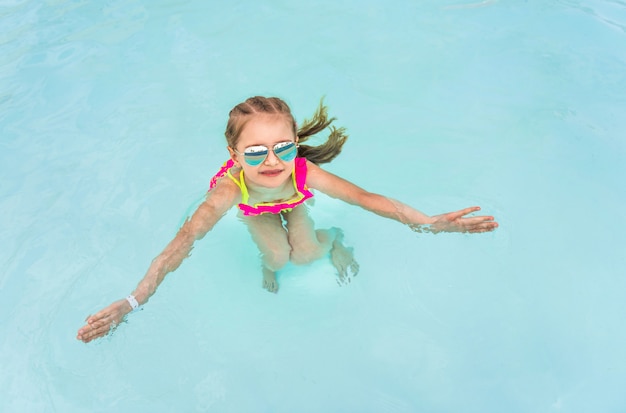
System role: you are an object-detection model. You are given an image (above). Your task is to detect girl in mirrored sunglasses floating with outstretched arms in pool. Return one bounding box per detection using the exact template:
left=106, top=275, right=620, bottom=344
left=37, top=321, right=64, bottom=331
left=77, top=96, right=498, bottom=343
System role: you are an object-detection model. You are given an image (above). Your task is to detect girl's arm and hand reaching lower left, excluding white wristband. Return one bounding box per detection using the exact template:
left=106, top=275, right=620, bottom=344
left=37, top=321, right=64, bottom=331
left=76, top=179, right=240, bottom=343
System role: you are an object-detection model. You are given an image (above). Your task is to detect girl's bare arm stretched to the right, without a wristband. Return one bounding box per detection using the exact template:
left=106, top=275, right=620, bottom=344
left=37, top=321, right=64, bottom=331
left=307, top=162, right=498, bottom=232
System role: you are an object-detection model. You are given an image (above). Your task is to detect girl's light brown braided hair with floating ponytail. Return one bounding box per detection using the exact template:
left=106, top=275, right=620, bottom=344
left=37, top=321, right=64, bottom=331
left=224, top=96, right=348, bottom=164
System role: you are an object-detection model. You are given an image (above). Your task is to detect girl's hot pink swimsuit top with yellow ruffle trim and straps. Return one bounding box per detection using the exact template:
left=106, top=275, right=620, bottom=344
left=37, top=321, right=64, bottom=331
left=209, top=158, right=313, bottom=216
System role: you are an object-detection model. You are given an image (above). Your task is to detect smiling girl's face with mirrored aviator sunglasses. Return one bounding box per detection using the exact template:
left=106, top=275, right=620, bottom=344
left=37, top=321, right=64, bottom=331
left=228, top=114, right=297, bottom=188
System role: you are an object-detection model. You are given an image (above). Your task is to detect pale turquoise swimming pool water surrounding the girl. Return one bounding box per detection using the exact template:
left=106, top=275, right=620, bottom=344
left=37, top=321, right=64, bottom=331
left=0, top=0, right=626, bottom=412
